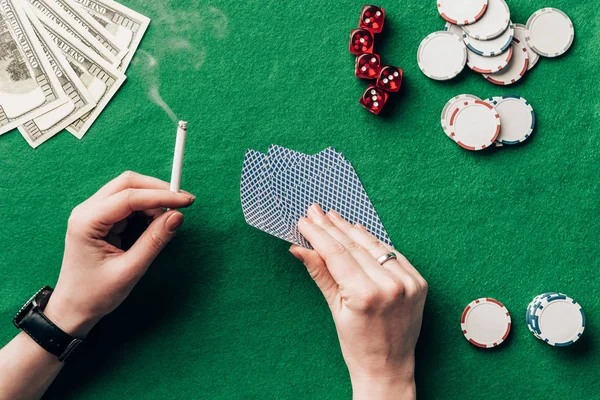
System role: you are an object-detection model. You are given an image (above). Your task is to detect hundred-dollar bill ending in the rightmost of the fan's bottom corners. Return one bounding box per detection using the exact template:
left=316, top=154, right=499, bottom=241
left=38, top=6, right=126, bottom=139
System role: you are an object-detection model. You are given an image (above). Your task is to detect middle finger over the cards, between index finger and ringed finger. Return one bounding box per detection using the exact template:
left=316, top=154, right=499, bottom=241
left=308, top=204, right=391, bottom=284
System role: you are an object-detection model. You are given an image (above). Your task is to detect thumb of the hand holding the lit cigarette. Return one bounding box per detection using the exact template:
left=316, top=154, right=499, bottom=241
left=122, top=210, right=184, bottom=279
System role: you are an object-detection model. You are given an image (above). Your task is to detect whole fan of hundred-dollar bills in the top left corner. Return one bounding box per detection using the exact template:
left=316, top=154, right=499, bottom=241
left=0, top=0, right=150, bottom=148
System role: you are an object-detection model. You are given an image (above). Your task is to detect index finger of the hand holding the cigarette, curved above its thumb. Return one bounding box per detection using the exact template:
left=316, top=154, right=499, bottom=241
left=91, top=189, right=196, bottom=226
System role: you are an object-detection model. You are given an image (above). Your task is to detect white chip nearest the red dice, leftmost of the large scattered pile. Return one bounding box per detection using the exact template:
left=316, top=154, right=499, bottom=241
left=417, top=31, right=467, bottom=81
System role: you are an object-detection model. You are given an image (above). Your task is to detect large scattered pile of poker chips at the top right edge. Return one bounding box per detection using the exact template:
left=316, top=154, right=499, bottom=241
left=417, top=0, right=575, bottom=85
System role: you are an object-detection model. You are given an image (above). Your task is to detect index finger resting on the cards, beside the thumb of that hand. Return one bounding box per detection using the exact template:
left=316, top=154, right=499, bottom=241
left=298, top=214, right=370, bottom=289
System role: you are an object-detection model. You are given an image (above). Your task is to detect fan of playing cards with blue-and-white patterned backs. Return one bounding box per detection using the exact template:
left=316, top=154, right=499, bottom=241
left=240, top=145, right=391, bottom=248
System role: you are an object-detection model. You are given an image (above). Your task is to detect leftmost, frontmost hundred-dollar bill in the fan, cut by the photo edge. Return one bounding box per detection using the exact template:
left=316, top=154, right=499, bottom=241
left=0, top=0, right=67, bottom=135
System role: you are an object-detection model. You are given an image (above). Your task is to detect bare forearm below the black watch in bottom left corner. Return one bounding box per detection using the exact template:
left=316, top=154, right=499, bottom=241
left=0, top=332, right=63, bottom=400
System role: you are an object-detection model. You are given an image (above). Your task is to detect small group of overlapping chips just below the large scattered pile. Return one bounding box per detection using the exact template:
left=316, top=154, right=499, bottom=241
left=441, top=94, right=535, bottom=151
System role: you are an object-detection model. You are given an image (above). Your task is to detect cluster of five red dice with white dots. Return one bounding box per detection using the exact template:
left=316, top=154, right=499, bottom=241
left=350, top=5, right=402, bottom=115
